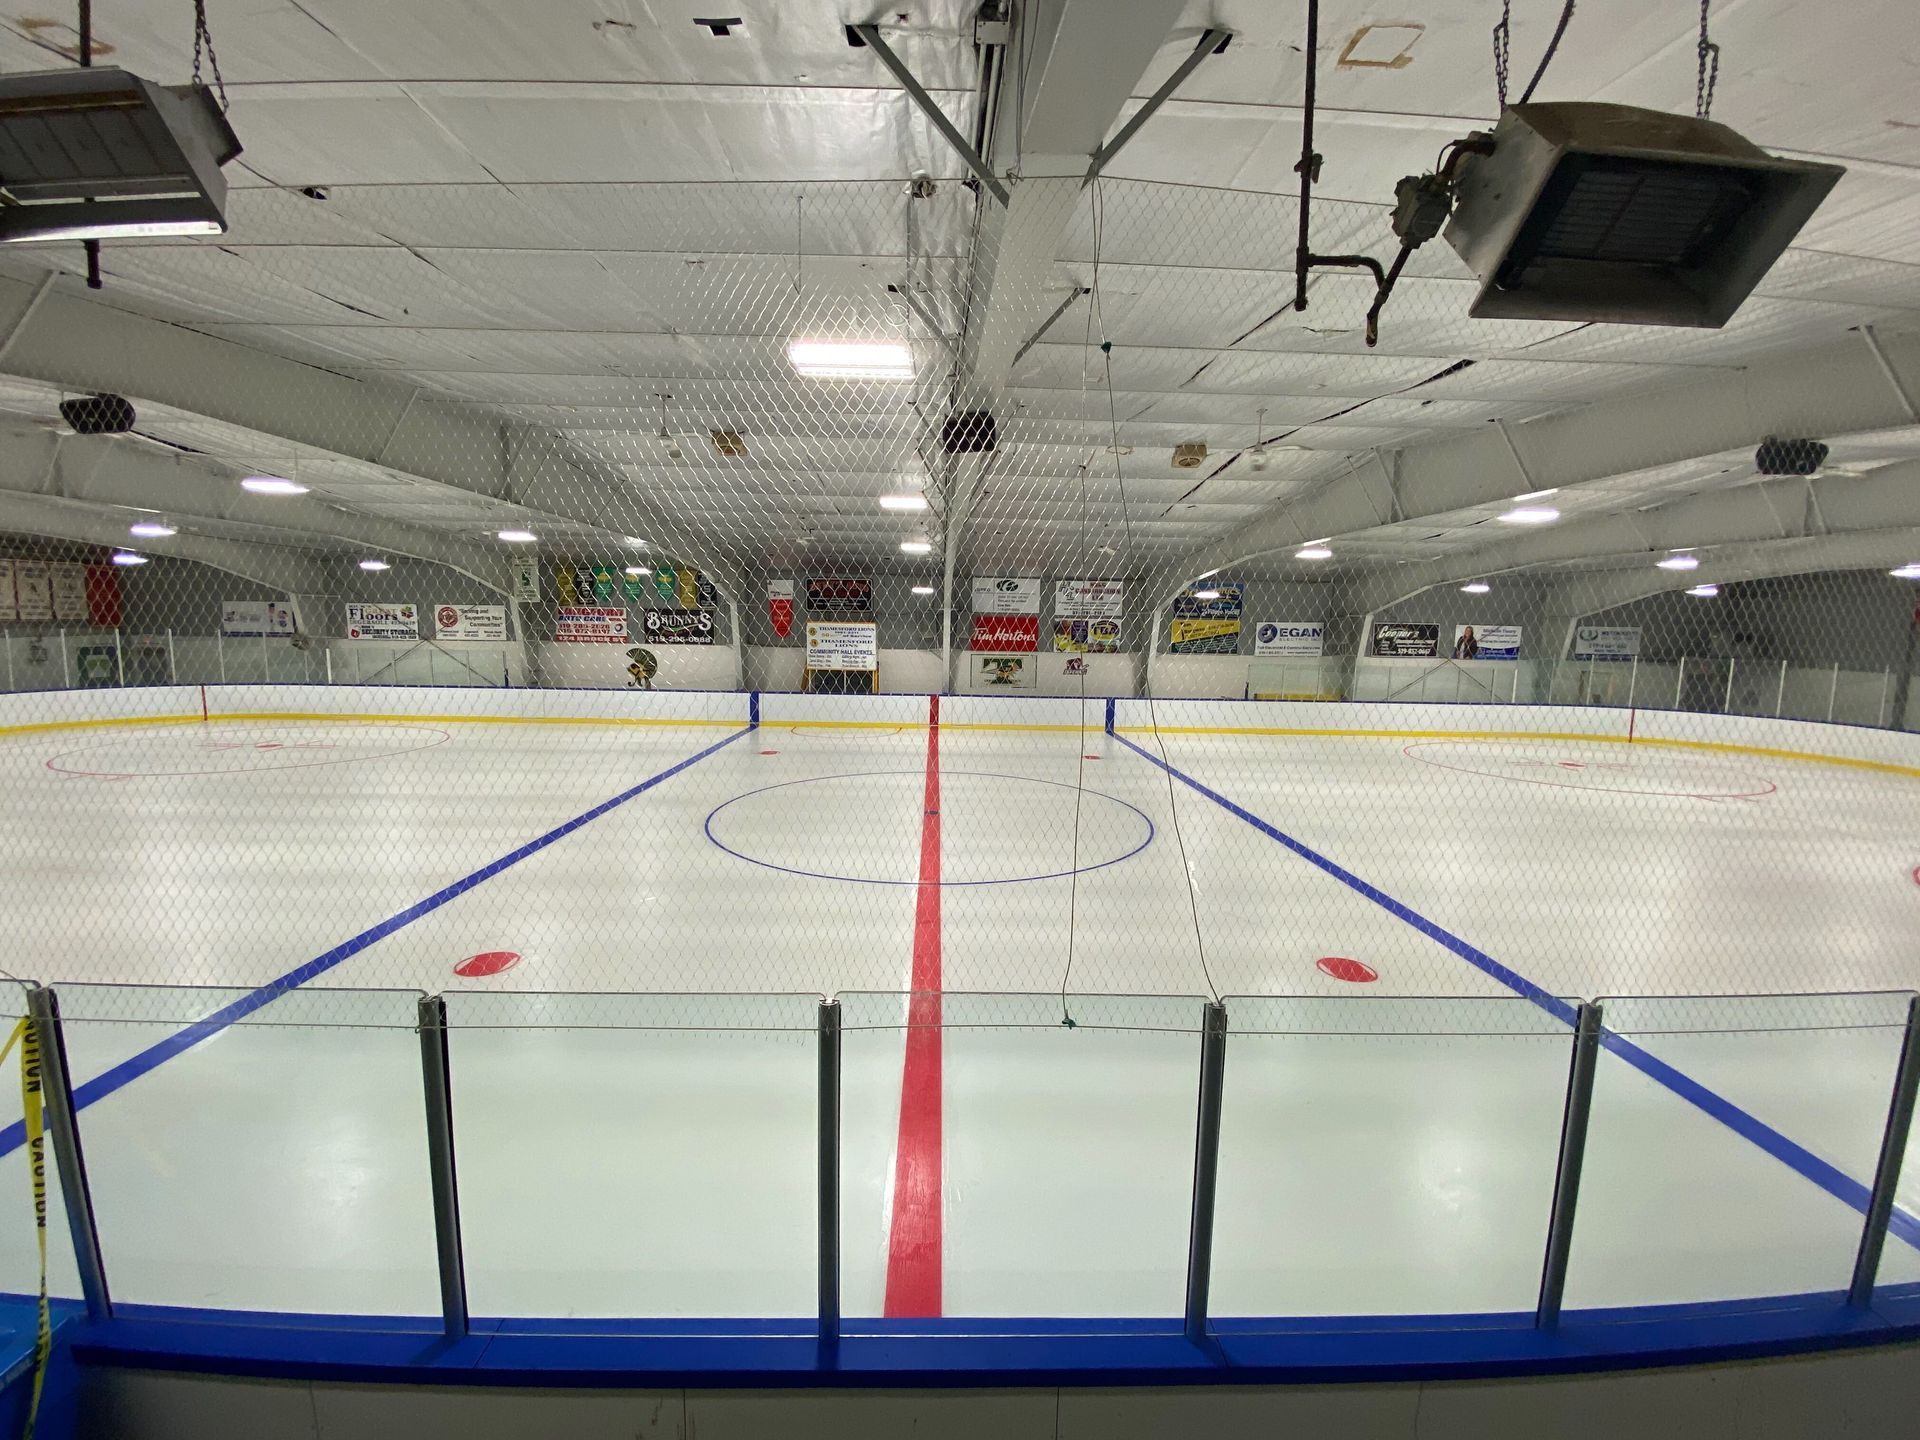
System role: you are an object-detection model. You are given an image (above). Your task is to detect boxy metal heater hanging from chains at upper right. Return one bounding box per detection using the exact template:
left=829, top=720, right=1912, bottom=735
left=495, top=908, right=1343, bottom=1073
left=1446, top=102, right=1845, bottom=328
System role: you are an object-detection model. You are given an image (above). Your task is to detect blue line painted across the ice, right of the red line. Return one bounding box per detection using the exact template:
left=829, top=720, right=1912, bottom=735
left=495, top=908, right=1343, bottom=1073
left=1114, top=735, right=1920, bottom=1248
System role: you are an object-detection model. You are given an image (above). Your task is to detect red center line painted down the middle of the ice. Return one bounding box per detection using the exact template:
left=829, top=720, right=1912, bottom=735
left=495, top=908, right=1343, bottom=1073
left=885, top=695, right=941, bottom=1317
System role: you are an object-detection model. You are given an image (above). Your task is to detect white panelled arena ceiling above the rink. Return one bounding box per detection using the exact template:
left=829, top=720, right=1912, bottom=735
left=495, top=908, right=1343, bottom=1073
left=0, top=0, right=1920, bottom=599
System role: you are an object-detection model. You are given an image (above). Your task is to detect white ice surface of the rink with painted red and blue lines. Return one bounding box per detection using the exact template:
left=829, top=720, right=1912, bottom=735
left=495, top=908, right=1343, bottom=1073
left=0, top=697, right=1920, bottom=1317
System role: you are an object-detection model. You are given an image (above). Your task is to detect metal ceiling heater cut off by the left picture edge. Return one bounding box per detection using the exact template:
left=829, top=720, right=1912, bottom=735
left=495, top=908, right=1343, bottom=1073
left=0, top=67, right=240, bottom=244
